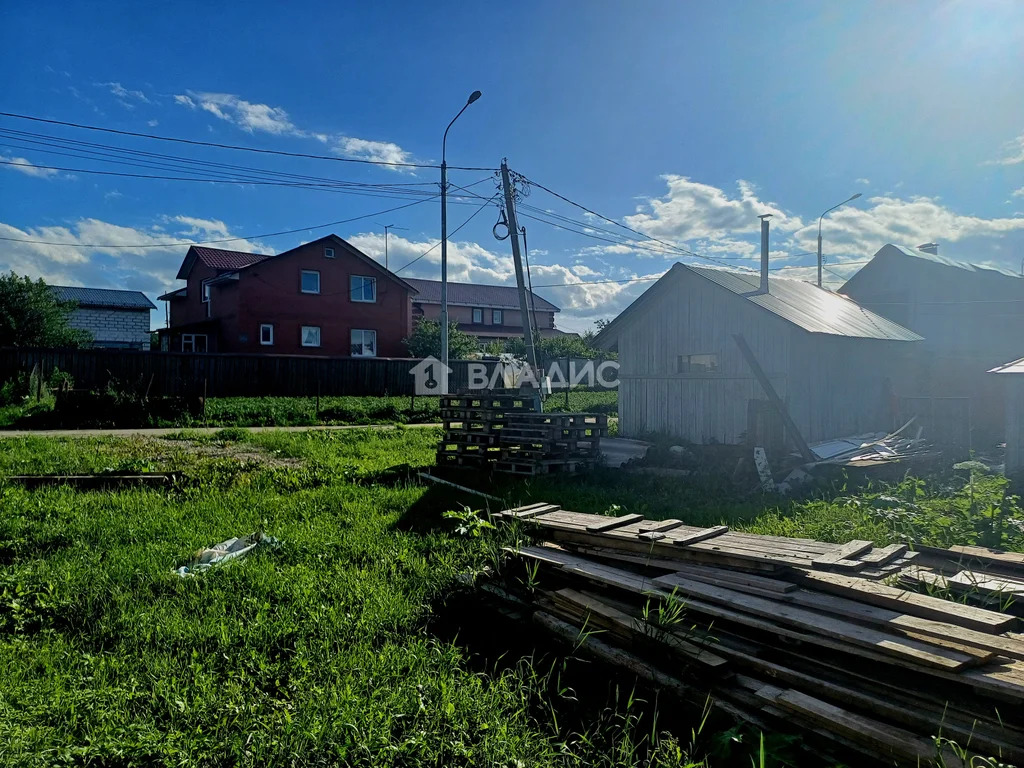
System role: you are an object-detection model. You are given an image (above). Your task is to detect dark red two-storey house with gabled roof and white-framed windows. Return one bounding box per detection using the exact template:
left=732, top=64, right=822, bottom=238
left=160, top=234, right=416, bottom=357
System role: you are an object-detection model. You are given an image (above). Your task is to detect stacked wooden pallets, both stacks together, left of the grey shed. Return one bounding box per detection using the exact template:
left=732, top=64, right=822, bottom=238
left=437, top=390, right=608, bottom=475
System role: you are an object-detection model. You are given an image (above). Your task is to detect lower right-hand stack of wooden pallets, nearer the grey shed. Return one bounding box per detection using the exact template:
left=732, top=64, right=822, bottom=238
left=496, top=413, right=608, bottom=475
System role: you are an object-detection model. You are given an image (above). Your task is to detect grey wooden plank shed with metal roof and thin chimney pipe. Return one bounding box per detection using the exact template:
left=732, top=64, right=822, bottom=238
left=596, top=264, right=921, bottom=443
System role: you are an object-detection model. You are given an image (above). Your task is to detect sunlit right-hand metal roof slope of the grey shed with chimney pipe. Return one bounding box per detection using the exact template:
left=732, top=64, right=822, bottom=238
left=682, top=264, right=922, bottom=341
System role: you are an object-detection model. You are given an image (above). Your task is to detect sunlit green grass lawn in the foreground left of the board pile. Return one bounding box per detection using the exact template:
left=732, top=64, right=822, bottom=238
left=0, top=430, right=716, bottom=768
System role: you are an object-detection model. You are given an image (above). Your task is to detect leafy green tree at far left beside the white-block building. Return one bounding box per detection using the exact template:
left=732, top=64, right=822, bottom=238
left=0, top=271, right=92, bottom=347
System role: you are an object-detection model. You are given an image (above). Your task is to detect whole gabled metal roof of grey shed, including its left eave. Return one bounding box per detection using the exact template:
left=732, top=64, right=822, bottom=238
left=594, top=263, right=922, bottom=348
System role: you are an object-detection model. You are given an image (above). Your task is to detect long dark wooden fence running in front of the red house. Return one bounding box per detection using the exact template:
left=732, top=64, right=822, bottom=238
left=0, top=347, right=614, bottom=397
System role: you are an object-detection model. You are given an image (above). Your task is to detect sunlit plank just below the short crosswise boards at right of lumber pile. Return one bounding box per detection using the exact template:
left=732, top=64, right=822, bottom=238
left=797, top=570, right=1017, bottom=634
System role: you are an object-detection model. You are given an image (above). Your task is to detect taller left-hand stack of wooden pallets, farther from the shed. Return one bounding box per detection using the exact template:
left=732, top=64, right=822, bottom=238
left=437, top=390, right=540, bottom=468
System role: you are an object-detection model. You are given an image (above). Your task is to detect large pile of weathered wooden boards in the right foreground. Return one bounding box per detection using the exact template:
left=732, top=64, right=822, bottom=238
left=483, top=504, right=1024, bottom=766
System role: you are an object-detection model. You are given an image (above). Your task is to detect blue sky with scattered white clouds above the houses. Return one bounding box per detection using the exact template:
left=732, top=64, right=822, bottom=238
left=0, top=0, right=1024, bottom=330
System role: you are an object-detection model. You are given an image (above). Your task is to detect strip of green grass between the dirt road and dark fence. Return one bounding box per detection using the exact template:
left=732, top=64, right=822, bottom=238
left=0, top=390, right=617, bottom=429
